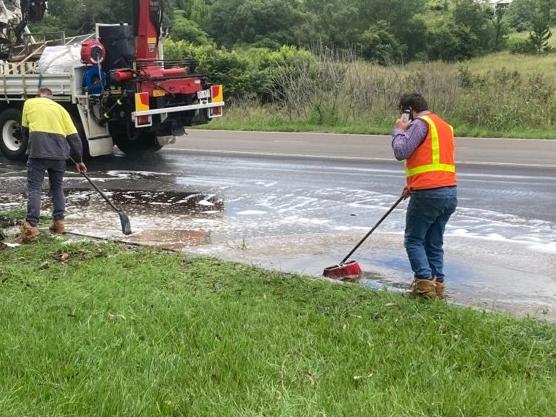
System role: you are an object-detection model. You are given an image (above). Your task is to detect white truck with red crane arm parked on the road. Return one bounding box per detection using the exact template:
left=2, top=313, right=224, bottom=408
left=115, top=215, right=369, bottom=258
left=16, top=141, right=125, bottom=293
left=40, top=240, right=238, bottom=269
left=0, top=0, right=225, bottom=160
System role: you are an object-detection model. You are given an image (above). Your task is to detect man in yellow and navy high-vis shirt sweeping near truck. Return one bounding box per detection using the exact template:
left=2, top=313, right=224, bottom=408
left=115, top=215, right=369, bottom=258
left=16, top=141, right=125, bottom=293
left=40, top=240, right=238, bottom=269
left=18, top=87, right=87, bottom=243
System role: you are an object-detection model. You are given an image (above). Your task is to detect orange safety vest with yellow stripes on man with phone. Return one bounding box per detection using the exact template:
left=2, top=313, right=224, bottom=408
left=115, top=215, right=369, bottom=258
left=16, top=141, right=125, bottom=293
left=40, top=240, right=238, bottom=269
left=405, top=113, right=457, bottom=190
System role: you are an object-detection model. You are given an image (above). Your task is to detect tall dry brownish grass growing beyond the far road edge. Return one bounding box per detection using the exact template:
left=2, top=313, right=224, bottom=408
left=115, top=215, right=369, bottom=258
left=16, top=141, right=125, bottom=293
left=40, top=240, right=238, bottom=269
left=220, top=52, right=556, bottom=134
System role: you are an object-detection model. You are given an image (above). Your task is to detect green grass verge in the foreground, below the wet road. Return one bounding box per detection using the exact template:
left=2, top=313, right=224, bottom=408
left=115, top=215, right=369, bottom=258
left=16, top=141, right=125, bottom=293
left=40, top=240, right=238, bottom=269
left=0, top=229, right=556, bottom=417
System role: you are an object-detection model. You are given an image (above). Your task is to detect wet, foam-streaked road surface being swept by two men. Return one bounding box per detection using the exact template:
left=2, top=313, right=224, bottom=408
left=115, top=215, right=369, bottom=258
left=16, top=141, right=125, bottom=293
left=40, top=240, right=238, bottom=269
left=0, top=132, right=556, bottom=319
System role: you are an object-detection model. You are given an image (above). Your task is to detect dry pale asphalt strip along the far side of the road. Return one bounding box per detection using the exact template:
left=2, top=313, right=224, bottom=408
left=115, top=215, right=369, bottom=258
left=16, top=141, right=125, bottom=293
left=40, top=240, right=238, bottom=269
left=167, top=130, right=556, bottom=168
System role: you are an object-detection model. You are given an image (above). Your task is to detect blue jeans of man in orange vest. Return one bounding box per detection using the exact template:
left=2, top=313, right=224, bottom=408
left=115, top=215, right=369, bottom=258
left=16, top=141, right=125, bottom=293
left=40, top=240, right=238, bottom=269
left=404, top=187, right=458, bottom=282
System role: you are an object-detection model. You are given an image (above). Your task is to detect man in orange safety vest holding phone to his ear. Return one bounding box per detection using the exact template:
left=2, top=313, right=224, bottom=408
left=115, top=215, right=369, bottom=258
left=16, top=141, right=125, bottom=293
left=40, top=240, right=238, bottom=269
left=392, top=93, right=457, bottom=299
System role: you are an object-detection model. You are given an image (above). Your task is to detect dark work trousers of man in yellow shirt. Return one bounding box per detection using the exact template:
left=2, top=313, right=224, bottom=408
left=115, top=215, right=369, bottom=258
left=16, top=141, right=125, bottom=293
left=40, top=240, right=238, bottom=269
left=27, top=158, right=66, bottom=227
